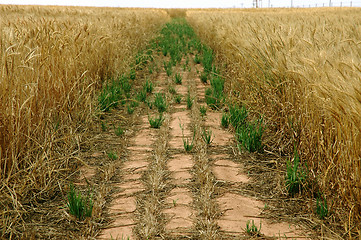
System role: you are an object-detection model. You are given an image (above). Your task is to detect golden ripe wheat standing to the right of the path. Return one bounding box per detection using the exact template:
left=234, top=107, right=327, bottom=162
left=187, top=8, right=361, bottom=236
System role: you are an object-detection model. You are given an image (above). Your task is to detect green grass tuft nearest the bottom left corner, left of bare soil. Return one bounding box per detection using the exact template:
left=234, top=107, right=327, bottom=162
left=67, top=184, right=93, bottom=221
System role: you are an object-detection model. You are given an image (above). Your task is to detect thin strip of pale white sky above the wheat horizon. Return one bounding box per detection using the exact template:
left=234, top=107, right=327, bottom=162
left=0, top=0, right=361, bottom=8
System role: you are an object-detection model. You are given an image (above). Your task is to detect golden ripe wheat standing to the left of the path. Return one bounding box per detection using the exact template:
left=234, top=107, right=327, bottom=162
left=0, top=5, right=169, bottom=236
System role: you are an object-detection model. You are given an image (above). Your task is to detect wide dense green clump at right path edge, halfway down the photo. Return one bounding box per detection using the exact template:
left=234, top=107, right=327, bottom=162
left=236, top=118, right=264, bottom=153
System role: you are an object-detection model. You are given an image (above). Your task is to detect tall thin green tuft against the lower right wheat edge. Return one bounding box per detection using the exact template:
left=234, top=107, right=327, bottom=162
left=286, top=147, right=306, bottom=196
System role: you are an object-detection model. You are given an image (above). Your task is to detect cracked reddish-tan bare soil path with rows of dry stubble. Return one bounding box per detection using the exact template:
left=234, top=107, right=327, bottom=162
left=79, top=56, right=307, bottom=239
